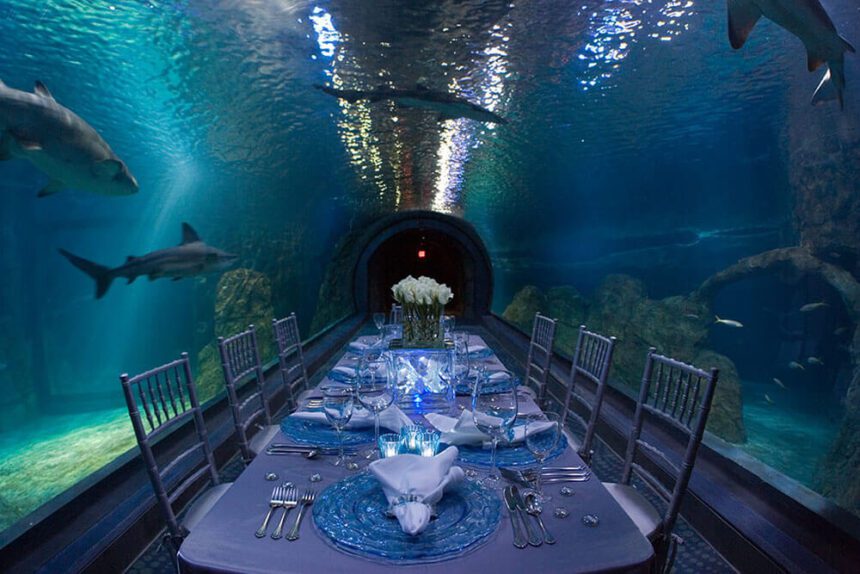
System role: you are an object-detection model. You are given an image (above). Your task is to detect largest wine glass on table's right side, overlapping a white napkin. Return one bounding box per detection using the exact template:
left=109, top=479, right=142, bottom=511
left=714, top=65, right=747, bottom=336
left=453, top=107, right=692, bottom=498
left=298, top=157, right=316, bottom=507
left=472, top=373, right=518, bottom=487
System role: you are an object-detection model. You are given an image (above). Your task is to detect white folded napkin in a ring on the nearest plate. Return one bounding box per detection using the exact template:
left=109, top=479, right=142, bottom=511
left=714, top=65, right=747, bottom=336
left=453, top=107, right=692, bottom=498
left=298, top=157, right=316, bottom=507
left=368, top=446, right=465, bottom=536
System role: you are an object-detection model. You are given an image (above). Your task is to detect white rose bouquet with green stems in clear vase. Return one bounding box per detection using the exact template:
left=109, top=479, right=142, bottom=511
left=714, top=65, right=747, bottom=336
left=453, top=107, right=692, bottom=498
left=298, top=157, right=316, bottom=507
left=391, top=275, right=454, bottom=347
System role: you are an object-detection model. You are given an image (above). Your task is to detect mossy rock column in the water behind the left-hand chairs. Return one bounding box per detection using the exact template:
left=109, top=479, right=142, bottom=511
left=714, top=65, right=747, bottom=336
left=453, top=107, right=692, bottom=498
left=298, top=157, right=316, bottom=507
left=195, top=268, right=277, bottom=403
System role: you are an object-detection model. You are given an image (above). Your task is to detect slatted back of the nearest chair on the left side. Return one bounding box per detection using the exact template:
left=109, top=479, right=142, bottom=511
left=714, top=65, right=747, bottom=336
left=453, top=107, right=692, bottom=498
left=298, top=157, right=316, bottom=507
left=120, top=353, right=220, bottom=549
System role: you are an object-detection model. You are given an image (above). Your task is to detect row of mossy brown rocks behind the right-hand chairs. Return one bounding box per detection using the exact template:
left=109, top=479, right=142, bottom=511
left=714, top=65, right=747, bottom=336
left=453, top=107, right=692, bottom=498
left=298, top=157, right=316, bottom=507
left=502, top=275, right=746, bottom=443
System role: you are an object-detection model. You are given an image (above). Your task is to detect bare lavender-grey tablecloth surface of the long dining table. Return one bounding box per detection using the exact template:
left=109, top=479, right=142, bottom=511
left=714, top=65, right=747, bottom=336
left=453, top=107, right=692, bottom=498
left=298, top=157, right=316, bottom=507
left=178, top=334, right=653, bottom=574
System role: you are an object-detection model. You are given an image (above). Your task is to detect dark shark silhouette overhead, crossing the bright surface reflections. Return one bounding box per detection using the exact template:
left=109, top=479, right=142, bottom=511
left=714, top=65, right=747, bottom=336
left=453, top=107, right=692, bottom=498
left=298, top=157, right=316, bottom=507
left=314, top=83, right=508, bottom=124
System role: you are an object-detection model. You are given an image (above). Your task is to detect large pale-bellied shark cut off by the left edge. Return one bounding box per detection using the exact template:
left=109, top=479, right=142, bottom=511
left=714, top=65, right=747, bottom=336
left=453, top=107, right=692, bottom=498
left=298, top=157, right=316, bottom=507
left=0, top=81, right=138, bottom=197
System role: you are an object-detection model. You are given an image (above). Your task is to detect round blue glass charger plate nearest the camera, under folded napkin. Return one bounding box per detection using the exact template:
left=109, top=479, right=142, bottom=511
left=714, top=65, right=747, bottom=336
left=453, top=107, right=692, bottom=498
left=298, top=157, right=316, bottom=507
left=312, top=473, right=501, bottom=564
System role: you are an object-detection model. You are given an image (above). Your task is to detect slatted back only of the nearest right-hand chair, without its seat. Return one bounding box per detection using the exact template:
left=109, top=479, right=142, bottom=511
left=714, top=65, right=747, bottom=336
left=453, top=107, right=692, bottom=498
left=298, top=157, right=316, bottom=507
left=621, top=348, right=719, bottom=541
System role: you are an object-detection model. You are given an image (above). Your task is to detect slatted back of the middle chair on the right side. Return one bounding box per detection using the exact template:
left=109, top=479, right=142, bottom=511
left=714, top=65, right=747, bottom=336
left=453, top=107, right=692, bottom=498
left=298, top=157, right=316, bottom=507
left=562, top=325, right=615, bottom=464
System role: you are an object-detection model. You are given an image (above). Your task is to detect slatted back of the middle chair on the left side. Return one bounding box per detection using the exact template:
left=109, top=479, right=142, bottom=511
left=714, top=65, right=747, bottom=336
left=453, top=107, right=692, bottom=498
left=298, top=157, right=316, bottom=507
left=218, top=325, right=272, bottom=464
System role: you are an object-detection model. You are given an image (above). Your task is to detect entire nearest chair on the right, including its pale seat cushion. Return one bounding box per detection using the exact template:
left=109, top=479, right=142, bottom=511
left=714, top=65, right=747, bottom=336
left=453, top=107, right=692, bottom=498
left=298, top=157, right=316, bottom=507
left=604, top=348, right=719, bottom=572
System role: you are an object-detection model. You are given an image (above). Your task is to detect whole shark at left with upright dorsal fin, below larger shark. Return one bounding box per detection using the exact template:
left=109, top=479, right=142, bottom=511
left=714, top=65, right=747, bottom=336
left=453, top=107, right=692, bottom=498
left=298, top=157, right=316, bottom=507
left=60, top=223, right=238, bottom=299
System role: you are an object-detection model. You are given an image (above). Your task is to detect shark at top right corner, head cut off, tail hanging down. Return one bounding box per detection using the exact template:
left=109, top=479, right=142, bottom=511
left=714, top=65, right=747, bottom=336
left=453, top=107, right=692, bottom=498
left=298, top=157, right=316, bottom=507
left=728, top=0, right=855, bottom=109
